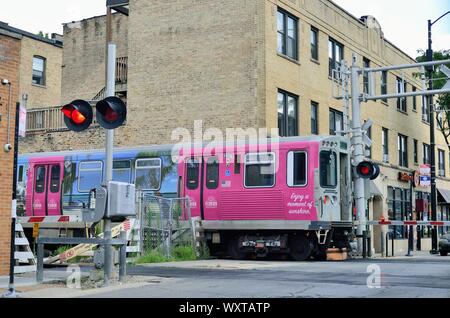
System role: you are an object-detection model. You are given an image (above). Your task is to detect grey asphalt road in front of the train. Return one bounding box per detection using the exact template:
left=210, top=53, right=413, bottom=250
left=81, top=254, right=450, bottom=298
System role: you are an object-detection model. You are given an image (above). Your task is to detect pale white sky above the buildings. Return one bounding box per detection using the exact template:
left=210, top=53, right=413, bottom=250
left=0, top=0, right=450, bottom=57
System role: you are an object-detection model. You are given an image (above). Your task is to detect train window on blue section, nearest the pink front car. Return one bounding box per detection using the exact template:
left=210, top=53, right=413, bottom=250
left=135, top=158, right=162, bottom=191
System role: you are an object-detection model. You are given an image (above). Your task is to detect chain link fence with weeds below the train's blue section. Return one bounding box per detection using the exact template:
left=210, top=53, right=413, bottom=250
left=138, top=193, right=195, bottom=258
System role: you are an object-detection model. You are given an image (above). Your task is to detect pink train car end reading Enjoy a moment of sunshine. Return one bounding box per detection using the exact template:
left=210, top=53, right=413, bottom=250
left=178, top=136, right=352, bottom=260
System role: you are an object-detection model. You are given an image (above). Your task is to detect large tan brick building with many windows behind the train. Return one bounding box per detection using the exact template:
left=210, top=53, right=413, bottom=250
left=19, top=0, right=450, bottom=251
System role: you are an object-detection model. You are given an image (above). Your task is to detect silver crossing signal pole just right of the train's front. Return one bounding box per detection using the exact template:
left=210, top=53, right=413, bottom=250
left=351, top=54, right=367, bottom=253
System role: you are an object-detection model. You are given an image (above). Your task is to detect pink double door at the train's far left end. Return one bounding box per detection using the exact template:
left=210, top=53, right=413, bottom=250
left=27, top=158, right=64, bottom=216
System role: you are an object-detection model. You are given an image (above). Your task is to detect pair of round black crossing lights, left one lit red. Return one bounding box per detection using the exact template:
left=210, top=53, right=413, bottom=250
left=61, top=97, right=127, bottom=132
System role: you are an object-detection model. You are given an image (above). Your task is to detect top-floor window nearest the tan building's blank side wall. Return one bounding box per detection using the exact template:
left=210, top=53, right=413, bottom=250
left=277, top=9, right=298, bottom=60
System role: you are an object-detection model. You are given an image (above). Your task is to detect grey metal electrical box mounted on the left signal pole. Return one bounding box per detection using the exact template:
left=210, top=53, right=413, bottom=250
left=106, top=181, right=136, bottom=219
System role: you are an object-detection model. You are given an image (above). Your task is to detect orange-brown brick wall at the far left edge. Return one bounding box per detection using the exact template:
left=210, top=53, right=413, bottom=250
left=0, top=34, right=20, bottom=275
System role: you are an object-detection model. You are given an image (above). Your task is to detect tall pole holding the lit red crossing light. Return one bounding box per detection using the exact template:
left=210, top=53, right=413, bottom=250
left=104, top=7, right=116, bottom=286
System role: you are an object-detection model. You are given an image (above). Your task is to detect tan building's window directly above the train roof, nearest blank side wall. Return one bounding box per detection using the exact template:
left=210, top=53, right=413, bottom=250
left=278, top=91, right=298, bottom=137
